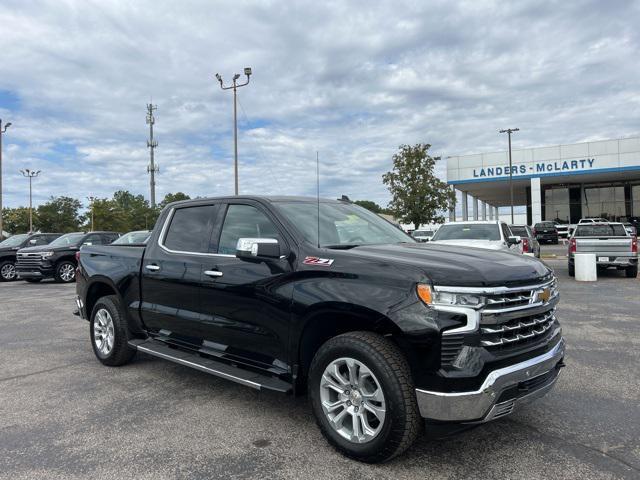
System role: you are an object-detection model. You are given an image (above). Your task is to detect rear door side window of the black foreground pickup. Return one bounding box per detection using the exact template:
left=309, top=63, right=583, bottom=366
left=164, top=205, right=215, bottom=253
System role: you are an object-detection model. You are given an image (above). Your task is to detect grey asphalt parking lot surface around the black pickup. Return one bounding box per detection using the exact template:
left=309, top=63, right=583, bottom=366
left=0, top=260, right=640, bottom=480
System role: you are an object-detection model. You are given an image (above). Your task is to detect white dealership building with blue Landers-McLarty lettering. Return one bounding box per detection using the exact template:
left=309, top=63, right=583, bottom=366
left=447, top=137, right=640, bottom=225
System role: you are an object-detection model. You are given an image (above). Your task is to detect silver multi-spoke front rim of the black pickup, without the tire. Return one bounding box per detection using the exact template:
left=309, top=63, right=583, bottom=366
left=320, top=357, right=386, bottom=443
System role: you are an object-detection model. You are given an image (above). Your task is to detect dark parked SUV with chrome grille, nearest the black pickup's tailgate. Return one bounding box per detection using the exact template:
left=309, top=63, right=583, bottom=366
left=16, top=232, right=120, bottom=283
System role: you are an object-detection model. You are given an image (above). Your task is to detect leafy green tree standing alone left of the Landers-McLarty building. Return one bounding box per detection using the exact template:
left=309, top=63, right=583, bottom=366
left=382, top=143, right=456, bottom=228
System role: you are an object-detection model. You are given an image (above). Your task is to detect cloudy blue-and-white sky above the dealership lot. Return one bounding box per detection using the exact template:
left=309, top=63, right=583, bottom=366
left=0, top=0, right=640, bottom=212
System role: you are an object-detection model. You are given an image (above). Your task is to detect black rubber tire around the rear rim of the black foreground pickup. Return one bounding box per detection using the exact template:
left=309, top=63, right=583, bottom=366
left=89, top=295, right=136, bottom=367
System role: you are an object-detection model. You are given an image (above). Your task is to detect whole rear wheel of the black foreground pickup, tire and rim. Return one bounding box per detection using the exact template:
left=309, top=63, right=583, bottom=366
left=90, top=295, right=136, bottom=367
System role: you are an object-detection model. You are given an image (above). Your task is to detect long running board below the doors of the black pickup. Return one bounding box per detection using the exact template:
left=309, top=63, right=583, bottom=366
left=128, top=339, right=292, bottom=393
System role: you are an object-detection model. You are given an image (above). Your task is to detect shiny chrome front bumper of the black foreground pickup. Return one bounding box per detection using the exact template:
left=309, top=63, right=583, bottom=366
left=416, top=339, right=565, bottom=423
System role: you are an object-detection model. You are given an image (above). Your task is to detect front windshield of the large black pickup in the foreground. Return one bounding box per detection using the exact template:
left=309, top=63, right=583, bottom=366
left=275, top=202, right=415, bottom=248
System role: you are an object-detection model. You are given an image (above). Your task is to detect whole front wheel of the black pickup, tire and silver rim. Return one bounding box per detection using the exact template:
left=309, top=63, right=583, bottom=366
left=308, top=332, right=422, bottom=463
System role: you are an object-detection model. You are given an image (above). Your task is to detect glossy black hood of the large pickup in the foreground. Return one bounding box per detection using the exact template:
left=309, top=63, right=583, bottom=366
left=349, top=242, right=551, bottom=287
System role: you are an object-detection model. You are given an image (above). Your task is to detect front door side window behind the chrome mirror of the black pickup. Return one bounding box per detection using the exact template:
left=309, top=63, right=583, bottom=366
left=218, top=205, right=282, bottom=255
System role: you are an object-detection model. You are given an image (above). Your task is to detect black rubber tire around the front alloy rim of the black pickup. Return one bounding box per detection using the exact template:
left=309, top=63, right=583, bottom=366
left=308, top=332, right=423, bottom=463
